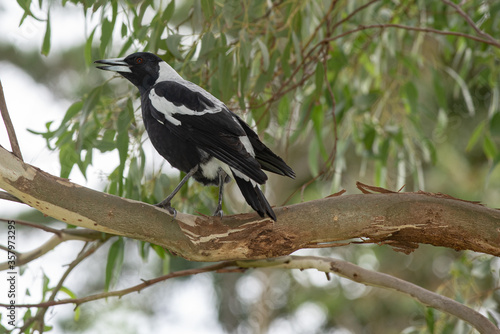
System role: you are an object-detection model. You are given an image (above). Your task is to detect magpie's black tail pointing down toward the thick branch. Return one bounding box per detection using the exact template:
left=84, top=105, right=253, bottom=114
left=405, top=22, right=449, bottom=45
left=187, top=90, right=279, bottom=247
left=232, top=170, right=276, bottom=221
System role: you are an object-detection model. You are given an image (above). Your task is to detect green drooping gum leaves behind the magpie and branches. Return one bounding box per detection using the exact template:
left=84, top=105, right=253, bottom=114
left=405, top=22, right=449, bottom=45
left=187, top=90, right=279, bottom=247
left=8, top=0, right=500, bottom=333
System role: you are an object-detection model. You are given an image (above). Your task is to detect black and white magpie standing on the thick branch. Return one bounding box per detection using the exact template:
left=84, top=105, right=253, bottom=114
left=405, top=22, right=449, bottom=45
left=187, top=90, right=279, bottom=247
left=95, top=52, right=295, bottom=221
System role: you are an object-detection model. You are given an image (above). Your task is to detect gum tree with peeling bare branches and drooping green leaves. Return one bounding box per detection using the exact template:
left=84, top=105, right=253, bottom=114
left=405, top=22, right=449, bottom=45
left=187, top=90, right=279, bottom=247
left=0, top=0, right=500, bottom=333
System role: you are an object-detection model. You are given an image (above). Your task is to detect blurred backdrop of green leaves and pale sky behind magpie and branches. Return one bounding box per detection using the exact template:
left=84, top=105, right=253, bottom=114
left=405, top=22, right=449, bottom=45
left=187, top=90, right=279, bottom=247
left=0, top=0, right=500, bottom=334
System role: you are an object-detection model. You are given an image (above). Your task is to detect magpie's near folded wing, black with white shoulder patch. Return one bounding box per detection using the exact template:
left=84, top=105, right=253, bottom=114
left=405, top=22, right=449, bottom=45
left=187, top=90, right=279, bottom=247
left=149, top=81, right=267, bottom=184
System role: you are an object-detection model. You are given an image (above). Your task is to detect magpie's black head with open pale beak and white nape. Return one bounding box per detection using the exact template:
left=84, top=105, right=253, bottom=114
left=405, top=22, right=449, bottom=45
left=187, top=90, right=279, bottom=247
left=94, top=52, right=181, bottom=93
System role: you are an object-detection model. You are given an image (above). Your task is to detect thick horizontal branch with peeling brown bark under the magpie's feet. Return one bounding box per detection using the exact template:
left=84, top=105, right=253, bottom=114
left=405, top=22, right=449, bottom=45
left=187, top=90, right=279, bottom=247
left=0, top=147, right=500, bottom=261
